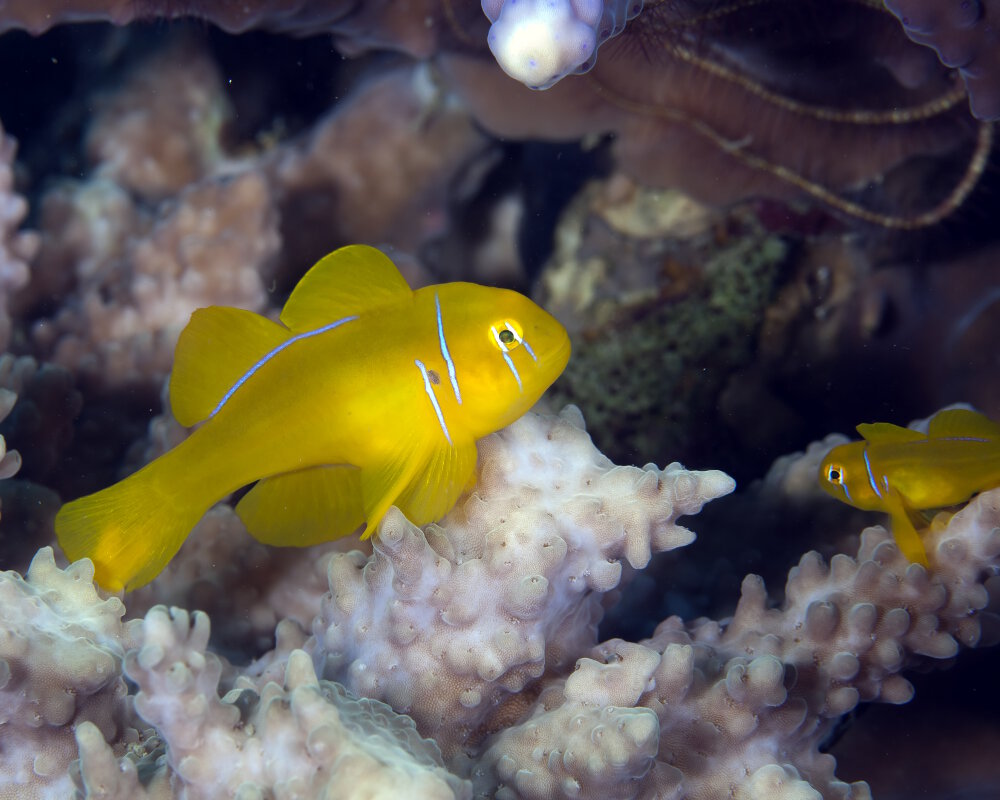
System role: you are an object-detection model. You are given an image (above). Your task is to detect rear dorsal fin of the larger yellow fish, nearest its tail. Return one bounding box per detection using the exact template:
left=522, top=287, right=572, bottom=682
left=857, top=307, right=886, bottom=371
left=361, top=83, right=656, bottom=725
left=170, top=306, right=292, bottom=425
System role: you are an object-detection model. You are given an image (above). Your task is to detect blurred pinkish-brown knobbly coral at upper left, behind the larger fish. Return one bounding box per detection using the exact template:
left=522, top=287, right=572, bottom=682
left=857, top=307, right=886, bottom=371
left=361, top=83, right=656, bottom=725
left=20, top=42, right=281, bottom=386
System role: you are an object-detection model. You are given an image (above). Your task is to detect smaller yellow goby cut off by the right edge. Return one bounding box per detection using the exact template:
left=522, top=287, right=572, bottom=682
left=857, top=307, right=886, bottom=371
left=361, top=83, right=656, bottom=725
left=819, top=408, right=1000, bottom=566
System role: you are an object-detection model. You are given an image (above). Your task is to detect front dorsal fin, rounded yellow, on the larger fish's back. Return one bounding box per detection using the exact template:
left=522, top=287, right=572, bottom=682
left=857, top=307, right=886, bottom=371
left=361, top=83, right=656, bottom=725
left=281, top=244, right=413, bottom=332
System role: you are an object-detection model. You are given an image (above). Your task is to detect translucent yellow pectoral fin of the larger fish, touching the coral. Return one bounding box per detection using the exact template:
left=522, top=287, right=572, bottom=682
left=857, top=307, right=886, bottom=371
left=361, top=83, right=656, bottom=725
left=361, top=434, right=476, bottom=538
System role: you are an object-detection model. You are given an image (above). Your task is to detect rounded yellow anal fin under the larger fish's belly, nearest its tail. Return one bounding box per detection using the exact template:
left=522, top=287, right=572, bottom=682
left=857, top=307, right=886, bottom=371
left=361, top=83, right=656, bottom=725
left=236, top=466, right=365, bottom=547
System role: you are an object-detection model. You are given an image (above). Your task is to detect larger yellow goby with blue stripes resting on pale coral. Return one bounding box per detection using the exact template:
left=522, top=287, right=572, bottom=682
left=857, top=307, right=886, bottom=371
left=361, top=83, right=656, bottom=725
left=55, top=245, right=570, bottom=591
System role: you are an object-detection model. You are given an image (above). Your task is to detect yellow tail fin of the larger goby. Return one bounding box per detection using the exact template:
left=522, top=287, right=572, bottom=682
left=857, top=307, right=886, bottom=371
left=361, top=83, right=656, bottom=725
left=56, top=463, right=205, bottom=592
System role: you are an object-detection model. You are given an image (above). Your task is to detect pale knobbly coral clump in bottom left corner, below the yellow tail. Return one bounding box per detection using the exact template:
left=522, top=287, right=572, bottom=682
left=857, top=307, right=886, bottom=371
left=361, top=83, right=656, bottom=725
left=0, top=549, right=132, bottom=800
